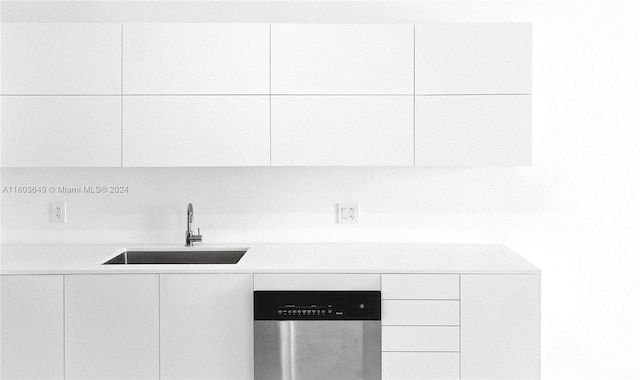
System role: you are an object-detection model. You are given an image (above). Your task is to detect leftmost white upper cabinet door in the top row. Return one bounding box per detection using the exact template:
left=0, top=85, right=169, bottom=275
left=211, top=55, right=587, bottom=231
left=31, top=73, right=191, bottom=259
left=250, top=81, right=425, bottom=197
left=2, top=23, right=121, bottom=95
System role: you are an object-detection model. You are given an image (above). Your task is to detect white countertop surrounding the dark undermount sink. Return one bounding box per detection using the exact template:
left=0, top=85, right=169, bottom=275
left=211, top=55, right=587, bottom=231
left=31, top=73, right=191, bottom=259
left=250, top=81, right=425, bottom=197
left=0, top=243, right=540, bottom=274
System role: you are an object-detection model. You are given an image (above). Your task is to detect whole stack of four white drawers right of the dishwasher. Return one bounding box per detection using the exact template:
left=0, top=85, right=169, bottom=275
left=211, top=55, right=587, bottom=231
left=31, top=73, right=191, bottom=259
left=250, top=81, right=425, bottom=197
left=382, top=274, right=460, bottom=380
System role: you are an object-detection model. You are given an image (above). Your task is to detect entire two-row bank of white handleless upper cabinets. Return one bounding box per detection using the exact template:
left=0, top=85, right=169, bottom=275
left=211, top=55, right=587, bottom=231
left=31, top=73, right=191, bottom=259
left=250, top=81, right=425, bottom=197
left=1, top=23, right=532, bottom=167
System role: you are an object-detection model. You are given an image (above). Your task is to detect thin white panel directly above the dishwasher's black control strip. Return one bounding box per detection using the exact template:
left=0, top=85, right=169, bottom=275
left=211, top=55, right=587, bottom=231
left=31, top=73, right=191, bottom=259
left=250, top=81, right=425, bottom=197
left=253, top=273, right=380, bottom=290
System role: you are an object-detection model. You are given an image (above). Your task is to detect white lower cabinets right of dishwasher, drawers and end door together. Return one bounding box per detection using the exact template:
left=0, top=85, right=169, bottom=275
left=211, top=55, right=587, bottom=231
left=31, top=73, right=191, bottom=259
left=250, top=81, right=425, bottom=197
left=381, top=273, right=540, bottom=380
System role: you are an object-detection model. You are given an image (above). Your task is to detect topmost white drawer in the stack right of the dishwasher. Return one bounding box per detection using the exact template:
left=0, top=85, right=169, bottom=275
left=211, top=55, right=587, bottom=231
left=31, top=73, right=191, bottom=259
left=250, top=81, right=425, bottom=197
left=381, top=274, right=460, bottom=299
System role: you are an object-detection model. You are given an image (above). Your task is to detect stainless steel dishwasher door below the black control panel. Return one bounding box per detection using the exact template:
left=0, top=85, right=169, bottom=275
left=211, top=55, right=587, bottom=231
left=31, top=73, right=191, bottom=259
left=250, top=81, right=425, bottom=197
left=254, top=320, right=382, bottom=380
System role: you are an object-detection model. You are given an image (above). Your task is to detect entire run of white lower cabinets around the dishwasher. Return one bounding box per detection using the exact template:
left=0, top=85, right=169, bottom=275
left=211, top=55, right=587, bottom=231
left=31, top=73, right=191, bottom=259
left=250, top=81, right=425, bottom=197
left=0, top=273, right=540, bottom=380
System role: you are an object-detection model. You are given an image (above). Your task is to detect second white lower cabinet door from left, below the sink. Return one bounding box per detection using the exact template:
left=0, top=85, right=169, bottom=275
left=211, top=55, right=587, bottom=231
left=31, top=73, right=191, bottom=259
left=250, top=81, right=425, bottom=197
left=65, top=274, right=160, bottom=379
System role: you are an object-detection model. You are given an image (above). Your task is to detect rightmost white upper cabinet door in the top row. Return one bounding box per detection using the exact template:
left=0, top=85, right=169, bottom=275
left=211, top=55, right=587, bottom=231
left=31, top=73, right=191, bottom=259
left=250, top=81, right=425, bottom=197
left=415, top=23, right=531, bottom=94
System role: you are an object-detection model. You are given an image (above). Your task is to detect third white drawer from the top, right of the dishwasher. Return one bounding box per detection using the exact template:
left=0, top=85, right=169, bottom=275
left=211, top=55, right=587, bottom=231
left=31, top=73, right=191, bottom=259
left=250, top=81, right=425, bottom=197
left=382, top=326, right=460, bottom=352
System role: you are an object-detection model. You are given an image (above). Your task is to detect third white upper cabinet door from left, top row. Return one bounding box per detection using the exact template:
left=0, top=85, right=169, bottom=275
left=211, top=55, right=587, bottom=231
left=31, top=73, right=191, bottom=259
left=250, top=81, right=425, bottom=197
left=271, top=24, right=413, bottom=94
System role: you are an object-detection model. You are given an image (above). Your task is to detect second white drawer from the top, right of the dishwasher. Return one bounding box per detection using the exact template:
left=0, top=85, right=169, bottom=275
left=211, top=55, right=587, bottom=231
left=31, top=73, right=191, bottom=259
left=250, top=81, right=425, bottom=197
left=382, top=300, right=460, bottom=326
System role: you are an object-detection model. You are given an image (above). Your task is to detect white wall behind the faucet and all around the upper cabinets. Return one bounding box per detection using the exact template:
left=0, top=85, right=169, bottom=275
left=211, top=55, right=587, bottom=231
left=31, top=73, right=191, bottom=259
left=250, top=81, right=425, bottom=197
left=2, top=0, right=640, bottom=379
